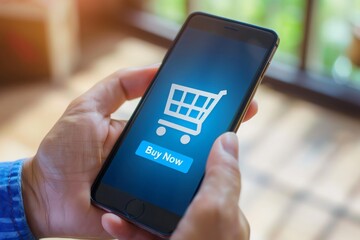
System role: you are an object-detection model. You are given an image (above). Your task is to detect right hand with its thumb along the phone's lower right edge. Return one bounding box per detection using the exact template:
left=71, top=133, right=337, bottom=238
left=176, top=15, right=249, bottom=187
left=103, top=131, right=250, bottom=240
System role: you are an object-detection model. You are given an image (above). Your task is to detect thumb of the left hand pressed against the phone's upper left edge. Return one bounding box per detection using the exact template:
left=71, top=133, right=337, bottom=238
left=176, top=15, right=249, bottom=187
left=83, top=66, right=158, bottom=116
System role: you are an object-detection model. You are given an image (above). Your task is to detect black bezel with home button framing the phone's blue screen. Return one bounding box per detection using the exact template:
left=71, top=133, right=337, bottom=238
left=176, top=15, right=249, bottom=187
left=91, top=12, right=279, bottom=237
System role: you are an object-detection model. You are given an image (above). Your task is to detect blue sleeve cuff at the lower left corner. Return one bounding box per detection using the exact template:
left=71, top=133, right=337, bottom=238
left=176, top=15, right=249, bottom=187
left=0, top=160, right=35, bottom=239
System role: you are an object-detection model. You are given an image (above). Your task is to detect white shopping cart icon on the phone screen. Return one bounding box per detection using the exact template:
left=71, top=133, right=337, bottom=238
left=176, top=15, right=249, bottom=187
left=156, top=84, right=227, bottom=144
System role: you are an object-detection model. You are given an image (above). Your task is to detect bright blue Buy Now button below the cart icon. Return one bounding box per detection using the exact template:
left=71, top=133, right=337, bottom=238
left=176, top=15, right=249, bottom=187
left=135, top=141, right=193, bottom=173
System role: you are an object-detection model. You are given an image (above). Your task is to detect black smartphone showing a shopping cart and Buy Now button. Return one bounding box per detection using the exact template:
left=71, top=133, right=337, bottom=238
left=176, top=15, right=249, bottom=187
left=91, top=13, right=279, bottom=237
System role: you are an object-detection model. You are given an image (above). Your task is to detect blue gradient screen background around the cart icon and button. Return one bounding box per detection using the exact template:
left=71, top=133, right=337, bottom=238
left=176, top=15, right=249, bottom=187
left=102, top=27, right=267, bottom=216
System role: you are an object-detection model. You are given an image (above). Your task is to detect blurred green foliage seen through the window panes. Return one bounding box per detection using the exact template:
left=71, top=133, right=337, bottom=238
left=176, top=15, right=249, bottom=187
left=149, top=0, right=360, bottom=87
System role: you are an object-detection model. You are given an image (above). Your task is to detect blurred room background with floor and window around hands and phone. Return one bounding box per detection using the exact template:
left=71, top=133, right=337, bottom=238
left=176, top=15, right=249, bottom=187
left=0, top=0, right=360, bottom=240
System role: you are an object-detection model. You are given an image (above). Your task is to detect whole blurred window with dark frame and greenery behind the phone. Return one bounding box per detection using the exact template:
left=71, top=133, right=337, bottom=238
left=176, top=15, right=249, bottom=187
left=123, top=0, right=360, bottom=109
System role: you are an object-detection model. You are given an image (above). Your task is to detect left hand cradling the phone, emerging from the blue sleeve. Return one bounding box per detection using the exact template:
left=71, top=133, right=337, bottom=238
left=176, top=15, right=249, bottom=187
left=22, top=67, right=256, bottom=239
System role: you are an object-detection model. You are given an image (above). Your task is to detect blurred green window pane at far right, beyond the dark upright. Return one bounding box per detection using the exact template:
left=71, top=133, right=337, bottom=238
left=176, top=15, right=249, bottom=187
left=307, top=0, right=360, bottom=88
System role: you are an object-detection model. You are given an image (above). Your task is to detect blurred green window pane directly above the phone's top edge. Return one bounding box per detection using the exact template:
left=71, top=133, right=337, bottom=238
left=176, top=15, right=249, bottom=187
left=188, top=0, right=305, bottom=64
